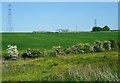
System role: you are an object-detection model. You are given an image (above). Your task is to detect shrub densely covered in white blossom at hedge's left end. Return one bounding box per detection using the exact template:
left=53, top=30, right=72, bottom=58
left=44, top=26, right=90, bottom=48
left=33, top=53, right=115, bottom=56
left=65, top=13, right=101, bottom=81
left=4, top=45, right=19, bottom=60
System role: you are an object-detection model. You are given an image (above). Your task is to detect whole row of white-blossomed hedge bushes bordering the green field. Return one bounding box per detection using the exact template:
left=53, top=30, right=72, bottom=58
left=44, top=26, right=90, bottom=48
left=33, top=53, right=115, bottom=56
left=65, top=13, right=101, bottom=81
left=4, top=40, right=120, bottom=60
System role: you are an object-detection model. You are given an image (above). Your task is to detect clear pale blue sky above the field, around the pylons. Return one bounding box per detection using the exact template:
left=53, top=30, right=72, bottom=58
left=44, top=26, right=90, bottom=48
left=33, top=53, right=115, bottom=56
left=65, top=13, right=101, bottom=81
left=2, top=2, right=118, bottom=32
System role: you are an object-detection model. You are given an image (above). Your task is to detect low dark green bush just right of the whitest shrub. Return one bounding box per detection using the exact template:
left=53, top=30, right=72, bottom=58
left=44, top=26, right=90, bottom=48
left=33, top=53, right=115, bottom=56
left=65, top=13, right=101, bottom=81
left=22, top=49, right=44, bottom=58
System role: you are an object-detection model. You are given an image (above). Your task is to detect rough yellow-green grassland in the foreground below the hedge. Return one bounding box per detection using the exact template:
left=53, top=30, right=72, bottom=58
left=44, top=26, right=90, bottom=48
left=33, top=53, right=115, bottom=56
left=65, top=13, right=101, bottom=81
left=2, top=51, right=119, bottom=81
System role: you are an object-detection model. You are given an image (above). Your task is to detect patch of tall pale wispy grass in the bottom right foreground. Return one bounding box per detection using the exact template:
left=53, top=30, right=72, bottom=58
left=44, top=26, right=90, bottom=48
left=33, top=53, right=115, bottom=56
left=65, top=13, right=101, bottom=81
left=43, top=64, right=119, bottom=81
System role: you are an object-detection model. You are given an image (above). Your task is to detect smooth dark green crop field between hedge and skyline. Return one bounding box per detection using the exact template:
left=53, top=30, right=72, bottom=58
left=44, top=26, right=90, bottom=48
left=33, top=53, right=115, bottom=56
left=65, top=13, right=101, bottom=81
left=2, top=31, right=118, bottom=51
